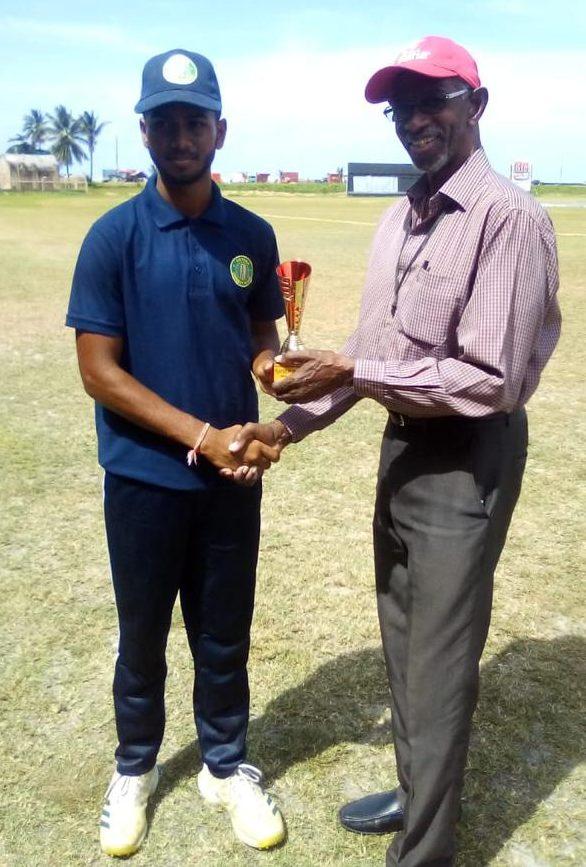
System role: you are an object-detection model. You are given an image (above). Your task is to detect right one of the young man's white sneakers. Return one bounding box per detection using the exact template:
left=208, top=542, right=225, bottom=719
left=197, top=764, right=285, bottom=849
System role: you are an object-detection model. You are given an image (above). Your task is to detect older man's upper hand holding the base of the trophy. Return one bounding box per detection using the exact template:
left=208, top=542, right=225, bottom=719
left=273, top=349, right=354, bottom=403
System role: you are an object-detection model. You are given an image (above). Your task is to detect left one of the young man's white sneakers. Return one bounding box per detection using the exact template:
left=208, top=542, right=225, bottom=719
left=100, top=765, right=159, bottom=858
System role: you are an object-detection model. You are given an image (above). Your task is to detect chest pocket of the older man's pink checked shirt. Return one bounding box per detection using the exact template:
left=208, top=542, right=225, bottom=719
left=395, top=268, right=467, bottom=346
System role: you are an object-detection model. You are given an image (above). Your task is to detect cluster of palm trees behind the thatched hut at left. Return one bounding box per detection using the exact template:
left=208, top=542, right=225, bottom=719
left=7, top=105, right=108, bottom=181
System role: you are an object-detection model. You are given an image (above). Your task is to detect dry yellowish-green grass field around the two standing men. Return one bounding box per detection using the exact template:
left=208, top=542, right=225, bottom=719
left=0, top=189, right=586, bottom=867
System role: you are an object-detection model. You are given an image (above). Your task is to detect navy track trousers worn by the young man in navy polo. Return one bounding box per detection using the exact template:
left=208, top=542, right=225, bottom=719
left=104, top=473, right=261, bottom=777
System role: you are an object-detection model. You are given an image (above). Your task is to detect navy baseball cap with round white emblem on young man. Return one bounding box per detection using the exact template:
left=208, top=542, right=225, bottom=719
left=134, top=48, right=222, bottom=114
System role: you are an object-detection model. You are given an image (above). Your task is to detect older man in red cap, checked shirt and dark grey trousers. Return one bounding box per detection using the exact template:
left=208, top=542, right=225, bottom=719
left=232, top=36, right=560, bottom=867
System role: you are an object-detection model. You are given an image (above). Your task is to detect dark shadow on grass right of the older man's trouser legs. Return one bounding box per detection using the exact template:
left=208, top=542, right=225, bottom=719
left=458, top=635, right=586, bottom=867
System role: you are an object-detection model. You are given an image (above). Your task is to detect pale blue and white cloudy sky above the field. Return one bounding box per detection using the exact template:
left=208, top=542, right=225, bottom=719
left=0, top=0, right=586, bottom=183
